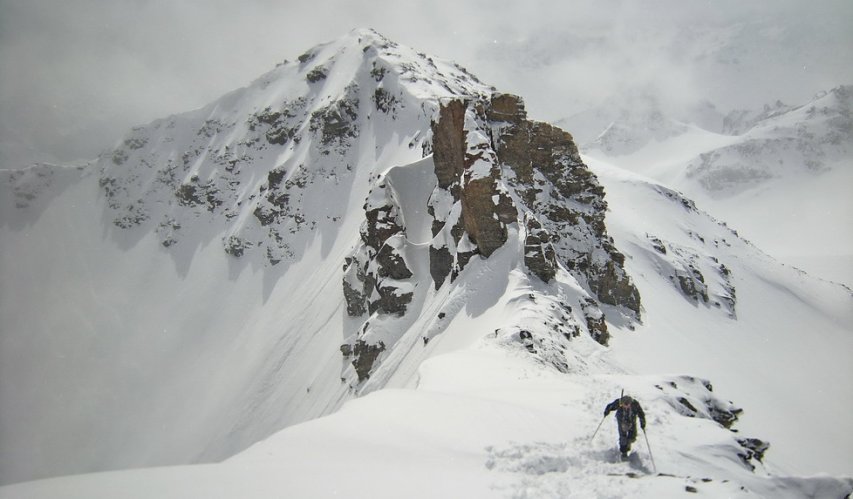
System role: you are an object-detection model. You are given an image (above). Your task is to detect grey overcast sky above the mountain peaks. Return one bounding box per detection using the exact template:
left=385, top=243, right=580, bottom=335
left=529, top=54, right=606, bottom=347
left=0, top=0, right=853, bottom=167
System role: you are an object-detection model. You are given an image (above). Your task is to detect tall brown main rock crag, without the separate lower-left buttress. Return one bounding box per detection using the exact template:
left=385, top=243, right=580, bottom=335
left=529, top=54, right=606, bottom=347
left=430, top=94, right=640, bottom=325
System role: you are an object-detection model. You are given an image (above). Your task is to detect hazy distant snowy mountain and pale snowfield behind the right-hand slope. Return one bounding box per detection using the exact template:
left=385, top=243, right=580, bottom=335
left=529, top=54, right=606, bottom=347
left=559, top=86, right=853, bottom=286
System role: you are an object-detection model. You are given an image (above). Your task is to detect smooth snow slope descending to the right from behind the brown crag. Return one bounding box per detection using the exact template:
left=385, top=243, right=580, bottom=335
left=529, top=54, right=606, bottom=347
left=586, top=158, right=853, bottom=474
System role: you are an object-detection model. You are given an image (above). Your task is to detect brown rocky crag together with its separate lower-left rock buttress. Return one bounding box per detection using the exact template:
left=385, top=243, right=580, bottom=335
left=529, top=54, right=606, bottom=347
left=343, top=93, right=640, bottom=381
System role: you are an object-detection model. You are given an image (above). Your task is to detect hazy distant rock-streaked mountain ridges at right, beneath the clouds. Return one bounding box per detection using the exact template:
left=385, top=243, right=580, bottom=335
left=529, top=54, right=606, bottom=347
left=558, top=85, right=853, bottom=197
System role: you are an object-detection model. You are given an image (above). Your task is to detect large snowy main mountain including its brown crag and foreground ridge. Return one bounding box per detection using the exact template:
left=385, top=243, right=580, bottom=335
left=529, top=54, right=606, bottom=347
left=0, top=30, right=853, bottom=497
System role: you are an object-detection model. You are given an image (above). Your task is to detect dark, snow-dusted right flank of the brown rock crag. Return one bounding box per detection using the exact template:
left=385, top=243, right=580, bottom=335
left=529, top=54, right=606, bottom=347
left=489, top=94, right=640, bottom=318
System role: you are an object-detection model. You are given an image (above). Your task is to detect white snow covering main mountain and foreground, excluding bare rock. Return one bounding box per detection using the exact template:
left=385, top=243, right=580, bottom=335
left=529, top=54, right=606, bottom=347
left=0, top=32, right=853, bottom=499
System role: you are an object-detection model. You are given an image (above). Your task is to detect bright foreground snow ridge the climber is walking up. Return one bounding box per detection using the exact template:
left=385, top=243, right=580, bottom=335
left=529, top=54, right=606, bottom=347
left=0, top=326, right=853, bottom=499
